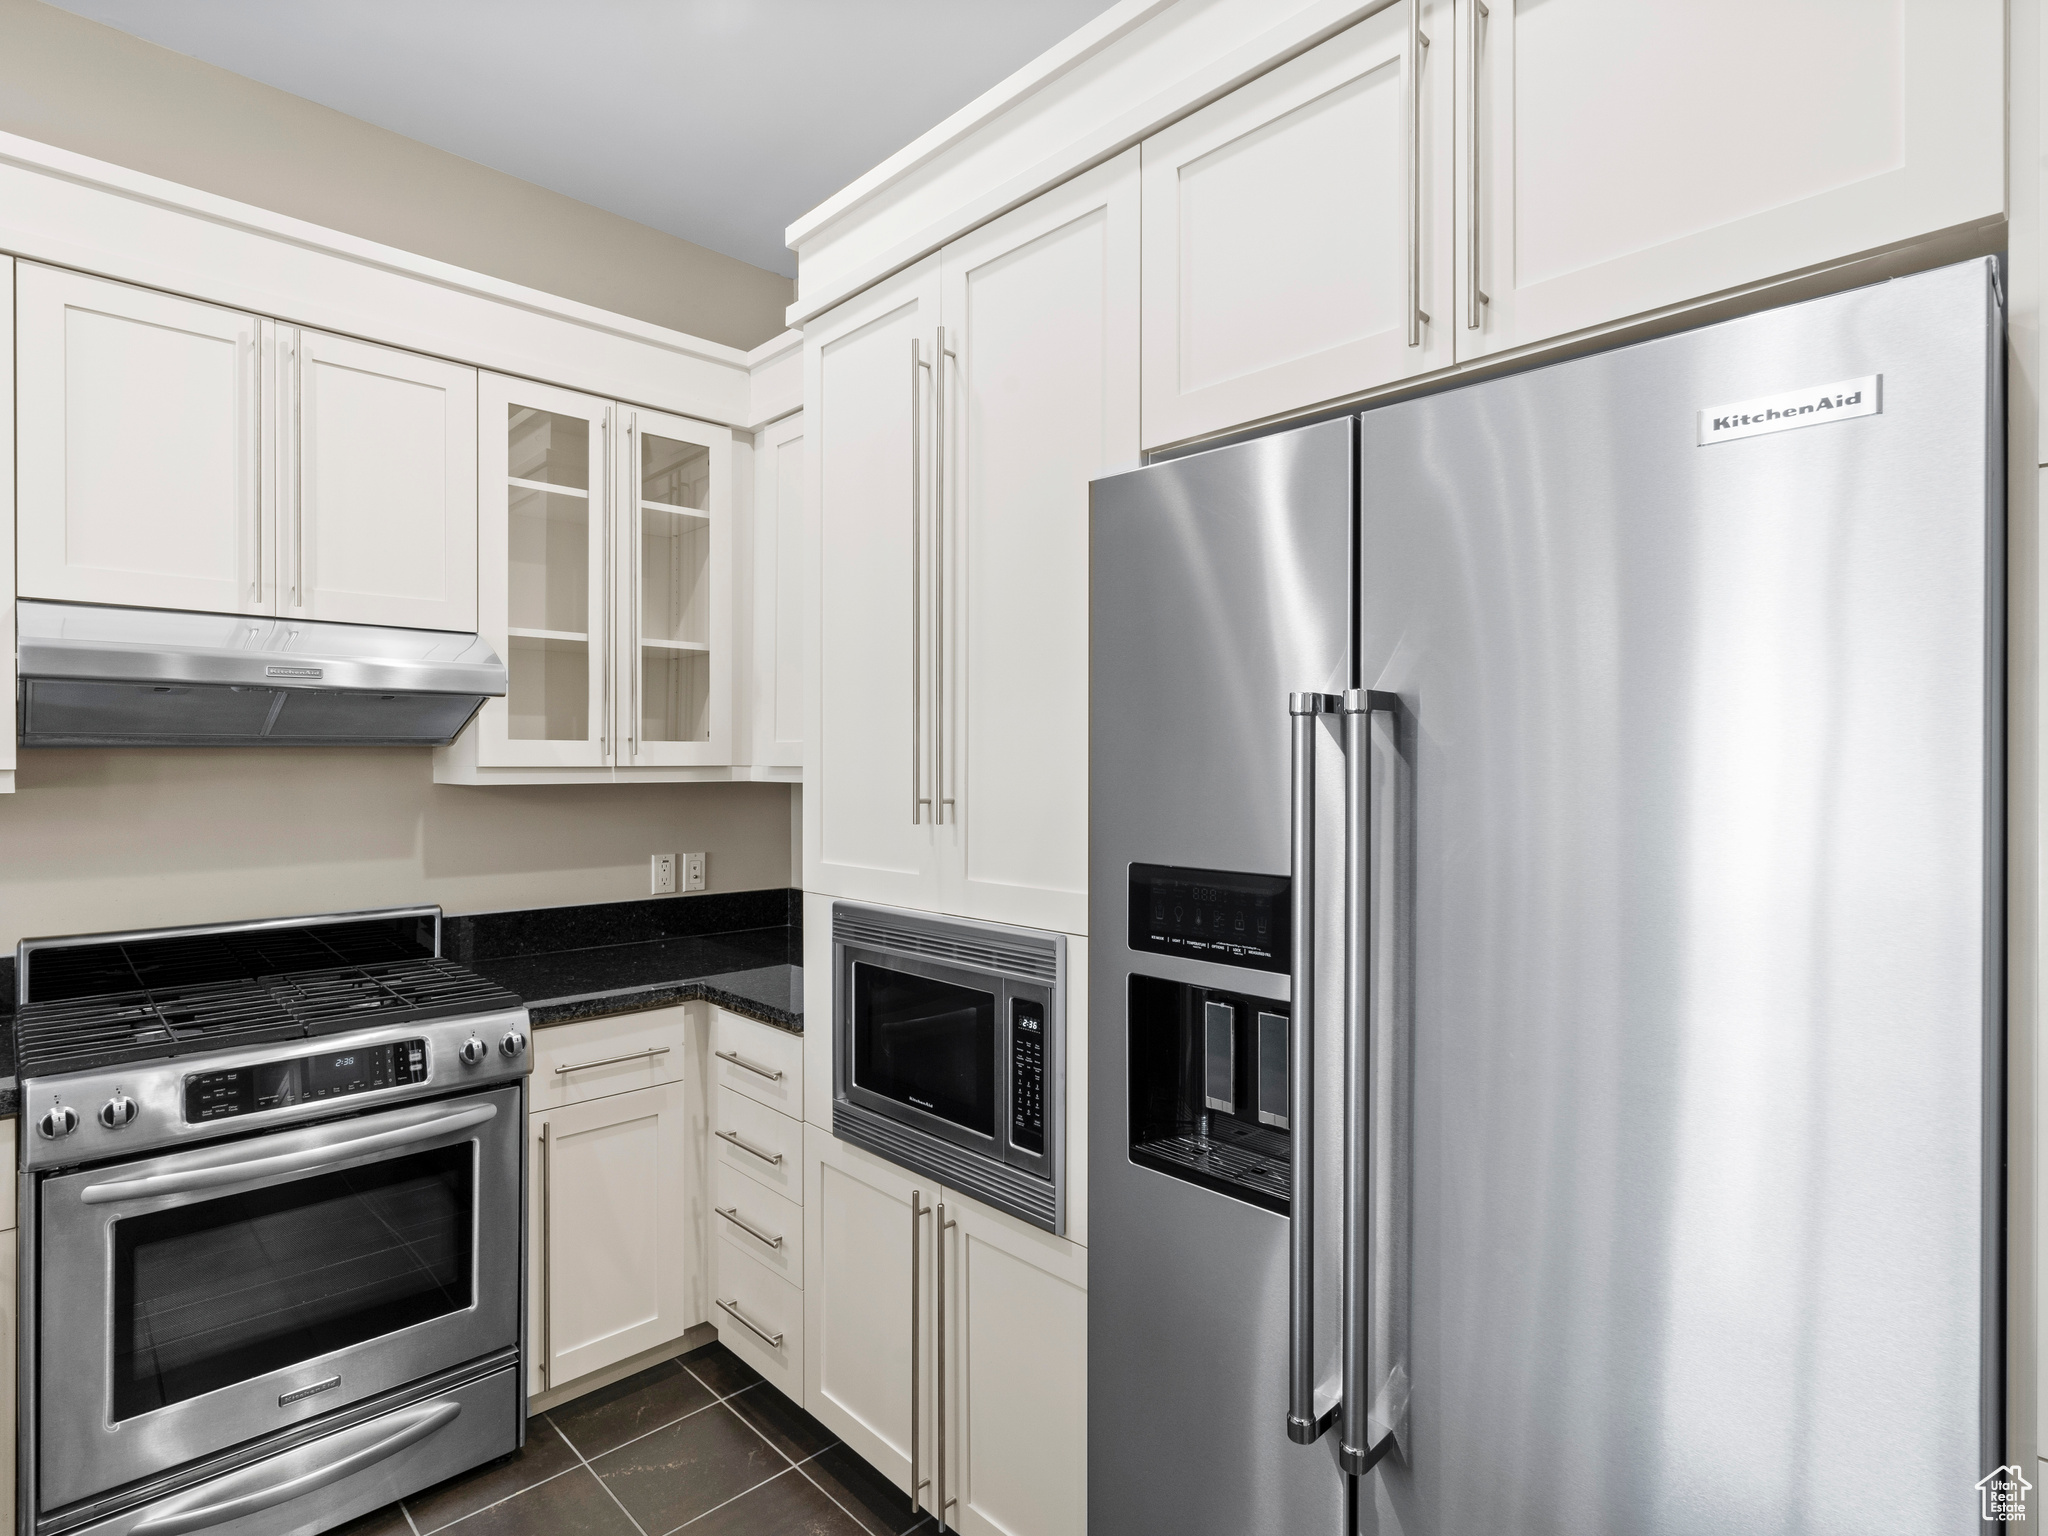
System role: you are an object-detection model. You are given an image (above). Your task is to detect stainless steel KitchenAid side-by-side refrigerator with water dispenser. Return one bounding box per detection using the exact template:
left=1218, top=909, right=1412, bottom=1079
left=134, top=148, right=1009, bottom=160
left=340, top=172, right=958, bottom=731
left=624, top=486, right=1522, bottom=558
left=1087, top=262, right=2003, bottom=1536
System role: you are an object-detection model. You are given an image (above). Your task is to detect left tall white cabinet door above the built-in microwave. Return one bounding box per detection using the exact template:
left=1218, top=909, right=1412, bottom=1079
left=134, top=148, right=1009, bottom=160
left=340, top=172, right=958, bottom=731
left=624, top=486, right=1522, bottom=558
left=803, top=256, right=938, bottom=907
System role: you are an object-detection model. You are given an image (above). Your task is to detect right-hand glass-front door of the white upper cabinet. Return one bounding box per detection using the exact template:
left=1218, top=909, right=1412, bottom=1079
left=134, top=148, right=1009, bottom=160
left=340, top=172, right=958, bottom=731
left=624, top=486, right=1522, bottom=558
left=616, top=410, right=733, bottom=766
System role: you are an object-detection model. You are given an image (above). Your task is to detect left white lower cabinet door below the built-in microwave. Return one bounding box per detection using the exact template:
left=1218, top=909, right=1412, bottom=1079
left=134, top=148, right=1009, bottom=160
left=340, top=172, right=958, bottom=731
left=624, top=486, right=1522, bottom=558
left=803, top=1126, right=938, bottom=1503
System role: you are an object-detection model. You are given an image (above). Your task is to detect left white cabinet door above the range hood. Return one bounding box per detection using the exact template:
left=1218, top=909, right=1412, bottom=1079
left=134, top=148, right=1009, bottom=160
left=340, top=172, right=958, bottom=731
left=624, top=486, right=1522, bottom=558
left=14, top=262, right=274, bottom=612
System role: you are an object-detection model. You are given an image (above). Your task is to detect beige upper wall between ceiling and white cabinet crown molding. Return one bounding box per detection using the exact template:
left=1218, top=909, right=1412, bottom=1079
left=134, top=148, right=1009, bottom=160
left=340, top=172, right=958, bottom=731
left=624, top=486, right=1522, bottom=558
left=0, top=0, right=795, bottom=348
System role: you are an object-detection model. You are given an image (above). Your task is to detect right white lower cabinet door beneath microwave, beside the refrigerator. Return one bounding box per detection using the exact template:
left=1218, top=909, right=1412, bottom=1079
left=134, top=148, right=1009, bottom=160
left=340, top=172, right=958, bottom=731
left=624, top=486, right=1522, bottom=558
left=942, top=1190, right=1087, bottom=1536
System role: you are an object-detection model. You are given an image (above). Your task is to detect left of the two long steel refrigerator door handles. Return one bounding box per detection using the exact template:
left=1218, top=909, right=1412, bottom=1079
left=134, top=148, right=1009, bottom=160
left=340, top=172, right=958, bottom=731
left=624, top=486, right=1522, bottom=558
left=1286, top=694, right=1343, bottom=1446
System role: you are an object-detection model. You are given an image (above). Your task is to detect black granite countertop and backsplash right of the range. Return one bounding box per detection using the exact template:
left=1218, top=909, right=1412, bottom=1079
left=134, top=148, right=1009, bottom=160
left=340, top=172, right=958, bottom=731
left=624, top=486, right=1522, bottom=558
left=442, top=891, right=803, bottom=1034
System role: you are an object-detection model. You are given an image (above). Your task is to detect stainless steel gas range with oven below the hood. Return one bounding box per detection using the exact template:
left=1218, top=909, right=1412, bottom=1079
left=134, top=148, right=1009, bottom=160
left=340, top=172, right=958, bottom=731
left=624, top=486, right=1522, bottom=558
left=16, top=907, right=528, bottom=1536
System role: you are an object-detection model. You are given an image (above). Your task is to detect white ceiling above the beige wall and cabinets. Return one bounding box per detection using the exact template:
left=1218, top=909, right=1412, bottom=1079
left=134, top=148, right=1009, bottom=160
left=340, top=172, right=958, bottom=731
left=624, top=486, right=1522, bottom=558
left=53, top=0, right=1112, bottom=276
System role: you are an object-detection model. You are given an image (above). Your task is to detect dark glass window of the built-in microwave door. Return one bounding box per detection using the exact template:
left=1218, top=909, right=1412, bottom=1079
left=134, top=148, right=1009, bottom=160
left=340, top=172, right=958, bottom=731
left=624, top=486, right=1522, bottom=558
left=854, top=963, right=995, bottom=1137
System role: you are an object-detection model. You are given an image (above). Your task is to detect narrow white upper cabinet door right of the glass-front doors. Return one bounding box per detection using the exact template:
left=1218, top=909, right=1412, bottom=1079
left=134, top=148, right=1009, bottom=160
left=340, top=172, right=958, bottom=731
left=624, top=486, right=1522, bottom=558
left=748, top=412, right=805, bottom=768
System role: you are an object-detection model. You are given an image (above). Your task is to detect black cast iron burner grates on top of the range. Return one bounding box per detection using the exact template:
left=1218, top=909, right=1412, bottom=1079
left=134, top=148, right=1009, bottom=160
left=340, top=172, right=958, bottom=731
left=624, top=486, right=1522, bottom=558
left=14, top=948, right=520, bottom=1077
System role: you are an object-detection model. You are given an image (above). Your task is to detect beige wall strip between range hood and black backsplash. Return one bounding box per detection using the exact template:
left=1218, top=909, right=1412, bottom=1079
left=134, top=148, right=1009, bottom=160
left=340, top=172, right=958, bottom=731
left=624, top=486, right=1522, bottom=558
left=0, top=748, right=791, bottom=952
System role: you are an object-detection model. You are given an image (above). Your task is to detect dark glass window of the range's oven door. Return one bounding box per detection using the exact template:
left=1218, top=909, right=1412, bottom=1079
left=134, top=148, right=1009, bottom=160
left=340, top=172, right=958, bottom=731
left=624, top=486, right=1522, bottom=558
left=113, top=1141, right=475, bottom=1419
